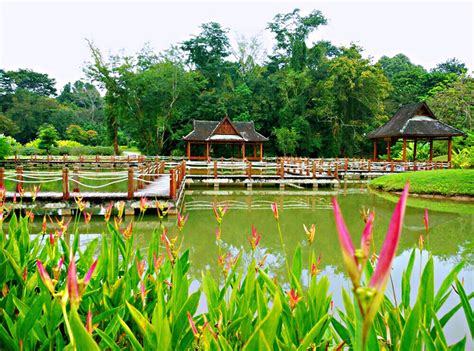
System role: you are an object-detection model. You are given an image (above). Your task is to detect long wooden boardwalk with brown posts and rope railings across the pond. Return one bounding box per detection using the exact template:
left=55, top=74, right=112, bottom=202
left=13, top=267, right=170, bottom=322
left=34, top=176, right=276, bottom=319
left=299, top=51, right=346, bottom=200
left=0, top=156, right=450, bottom=212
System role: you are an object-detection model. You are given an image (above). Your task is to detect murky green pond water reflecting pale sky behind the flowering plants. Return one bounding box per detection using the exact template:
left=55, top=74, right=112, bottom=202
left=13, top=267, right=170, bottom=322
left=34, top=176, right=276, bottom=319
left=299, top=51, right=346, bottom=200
left=18, top=188, right=474, bottom=347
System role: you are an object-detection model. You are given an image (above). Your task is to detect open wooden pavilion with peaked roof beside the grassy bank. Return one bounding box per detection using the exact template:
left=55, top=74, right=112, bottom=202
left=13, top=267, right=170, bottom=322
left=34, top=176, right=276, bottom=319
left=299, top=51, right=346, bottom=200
left=367, top=102, right=464, bottom=162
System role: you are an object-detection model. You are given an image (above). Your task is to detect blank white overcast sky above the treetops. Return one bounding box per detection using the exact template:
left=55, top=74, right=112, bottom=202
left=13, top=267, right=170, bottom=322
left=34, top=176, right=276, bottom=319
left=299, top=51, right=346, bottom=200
left=0, top=0, right=474, bottom=88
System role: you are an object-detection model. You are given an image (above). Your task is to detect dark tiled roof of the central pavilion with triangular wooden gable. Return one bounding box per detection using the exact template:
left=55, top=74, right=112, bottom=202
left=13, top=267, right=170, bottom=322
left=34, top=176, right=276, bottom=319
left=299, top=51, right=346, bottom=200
left=183, top=117, right=268, bottom=142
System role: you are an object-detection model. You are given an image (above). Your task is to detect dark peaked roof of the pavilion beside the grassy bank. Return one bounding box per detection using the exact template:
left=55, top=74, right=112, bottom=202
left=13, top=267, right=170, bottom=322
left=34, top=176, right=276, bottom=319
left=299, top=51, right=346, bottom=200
left=367, top=102, right=464, bottom=139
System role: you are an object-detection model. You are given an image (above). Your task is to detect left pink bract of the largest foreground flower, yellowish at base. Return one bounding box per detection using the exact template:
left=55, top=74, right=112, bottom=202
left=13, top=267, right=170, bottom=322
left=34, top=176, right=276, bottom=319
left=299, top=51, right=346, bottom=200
left=332, top=198, right=360, bottom=287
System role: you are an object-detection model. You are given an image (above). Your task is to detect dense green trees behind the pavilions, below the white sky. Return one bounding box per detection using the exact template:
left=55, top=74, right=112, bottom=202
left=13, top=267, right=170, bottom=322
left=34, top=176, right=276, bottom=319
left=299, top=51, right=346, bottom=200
left=0, top=9, right=474, bottom=157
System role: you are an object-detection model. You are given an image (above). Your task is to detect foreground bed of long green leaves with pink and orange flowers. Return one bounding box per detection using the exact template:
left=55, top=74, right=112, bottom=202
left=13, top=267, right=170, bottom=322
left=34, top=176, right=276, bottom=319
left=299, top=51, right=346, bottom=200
left=0, top=189, right=474, bottom=350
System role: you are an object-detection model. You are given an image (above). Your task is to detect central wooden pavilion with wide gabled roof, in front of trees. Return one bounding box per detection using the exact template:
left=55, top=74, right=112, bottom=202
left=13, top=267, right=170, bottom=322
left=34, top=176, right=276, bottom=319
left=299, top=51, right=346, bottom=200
left=183, top=116, right=268, bottom=161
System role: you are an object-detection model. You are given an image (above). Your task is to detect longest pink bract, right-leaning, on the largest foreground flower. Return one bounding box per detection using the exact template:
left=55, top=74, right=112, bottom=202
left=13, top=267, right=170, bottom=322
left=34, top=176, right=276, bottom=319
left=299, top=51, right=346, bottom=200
left=369, top=183, right=409, bottom=291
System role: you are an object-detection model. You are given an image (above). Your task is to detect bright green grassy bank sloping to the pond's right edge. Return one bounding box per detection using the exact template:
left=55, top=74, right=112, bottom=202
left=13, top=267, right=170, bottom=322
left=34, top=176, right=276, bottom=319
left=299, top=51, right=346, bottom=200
left=369, top=169, right=474, bottom=196
